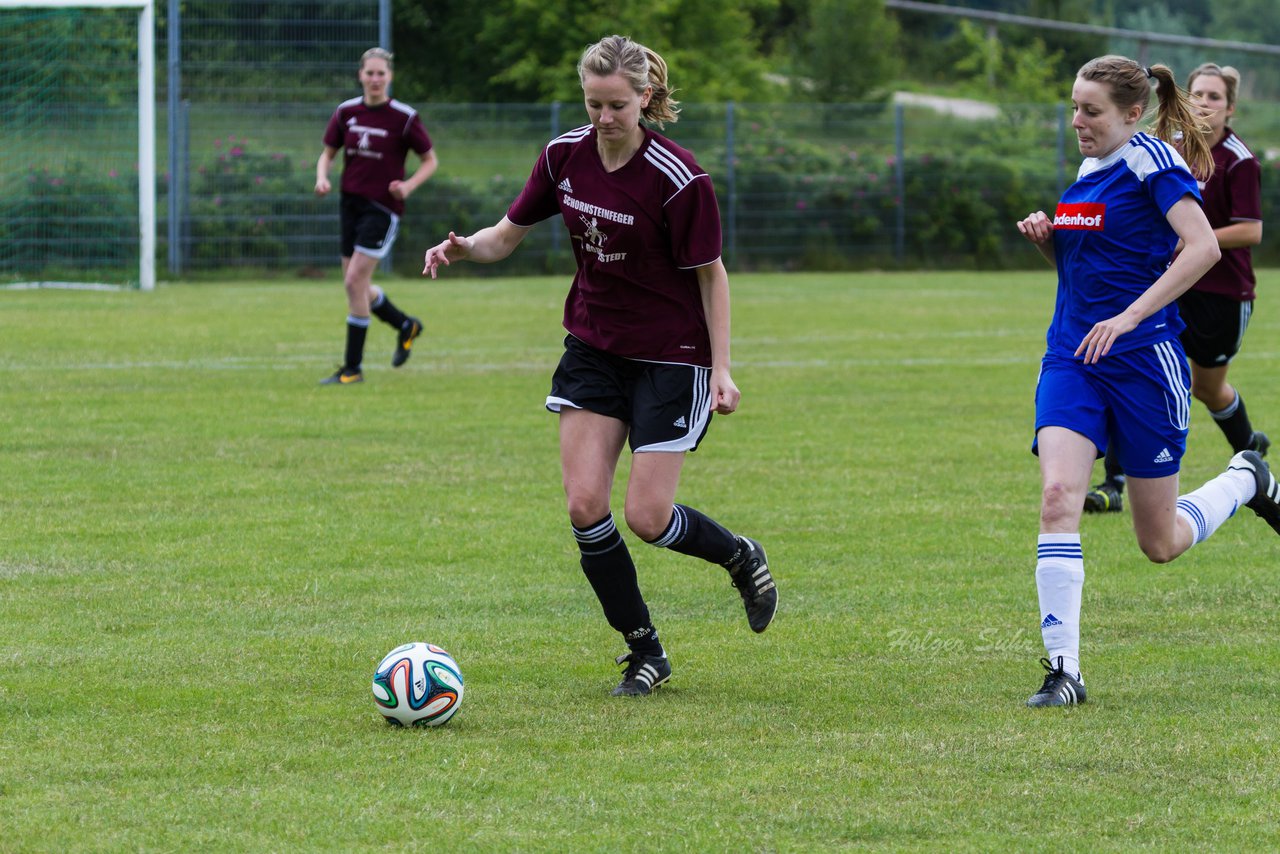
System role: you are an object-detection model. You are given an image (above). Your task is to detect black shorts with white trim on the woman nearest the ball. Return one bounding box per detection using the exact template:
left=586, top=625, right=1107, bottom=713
left=547, top=335, right=712, bottom=453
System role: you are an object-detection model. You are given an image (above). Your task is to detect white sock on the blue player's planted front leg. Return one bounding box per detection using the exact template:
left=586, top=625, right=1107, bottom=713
left=1036, top=534, right=1084, bottom=679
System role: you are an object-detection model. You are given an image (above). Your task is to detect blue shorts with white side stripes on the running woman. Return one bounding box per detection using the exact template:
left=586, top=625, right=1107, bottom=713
left=1032, top=339, right=1192, bottom=478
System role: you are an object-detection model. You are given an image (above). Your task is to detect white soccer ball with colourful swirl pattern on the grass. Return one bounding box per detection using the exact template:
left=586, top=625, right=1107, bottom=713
left=372, top=644, right=462, bottom=726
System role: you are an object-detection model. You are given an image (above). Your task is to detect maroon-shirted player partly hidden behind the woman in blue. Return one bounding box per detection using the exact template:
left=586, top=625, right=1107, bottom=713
left=1084, top=63, right=1271, bottom=512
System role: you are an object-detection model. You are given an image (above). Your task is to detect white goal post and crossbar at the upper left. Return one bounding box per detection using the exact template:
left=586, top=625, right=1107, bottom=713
left=0, top=0, right=156, bottom=291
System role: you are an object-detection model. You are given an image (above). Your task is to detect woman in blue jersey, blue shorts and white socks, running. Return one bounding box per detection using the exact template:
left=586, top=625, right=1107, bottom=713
left=1018, top=56, right=1280, bottom=707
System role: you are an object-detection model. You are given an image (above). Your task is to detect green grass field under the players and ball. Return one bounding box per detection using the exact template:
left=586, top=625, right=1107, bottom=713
left=0, top=270, right=1280, bottom=851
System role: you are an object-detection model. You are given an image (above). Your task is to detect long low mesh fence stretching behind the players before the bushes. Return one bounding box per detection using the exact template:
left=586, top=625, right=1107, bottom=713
left=162, top=99, right=1280, bottom=275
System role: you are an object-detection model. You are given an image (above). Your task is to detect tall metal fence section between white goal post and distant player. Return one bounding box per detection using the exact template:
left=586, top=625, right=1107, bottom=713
left=157, top=0, right=390, bottom=274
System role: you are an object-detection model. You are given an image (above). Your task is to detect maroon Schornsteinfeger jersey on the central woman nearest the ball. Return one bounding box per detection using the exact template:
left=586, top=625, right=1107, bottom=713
left=507, top=125, right=721, bottom=367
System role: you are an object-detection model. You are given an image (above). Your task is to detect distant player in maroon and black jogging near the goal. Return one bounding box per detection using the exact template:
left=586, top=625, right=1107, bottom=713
left=316, top=47, right=438, bottom=385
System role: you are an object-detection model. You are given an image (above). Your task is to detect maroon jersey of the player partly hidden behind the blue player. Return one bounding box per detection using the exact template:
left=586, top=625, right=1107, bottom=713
left=1196, top=128, right=1262, bottom=302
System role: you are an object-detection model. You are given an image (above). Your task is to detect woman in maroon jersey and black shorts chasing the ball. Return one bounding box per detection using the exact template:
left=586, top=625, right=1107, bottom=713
left=422, top=36, right=778, bottom=695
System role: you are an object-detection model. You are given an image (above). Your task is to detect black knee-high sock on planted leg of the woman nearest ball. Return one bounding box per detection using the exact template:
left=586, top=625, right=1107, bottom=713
left=573, top=513, right=662, bottom=656
